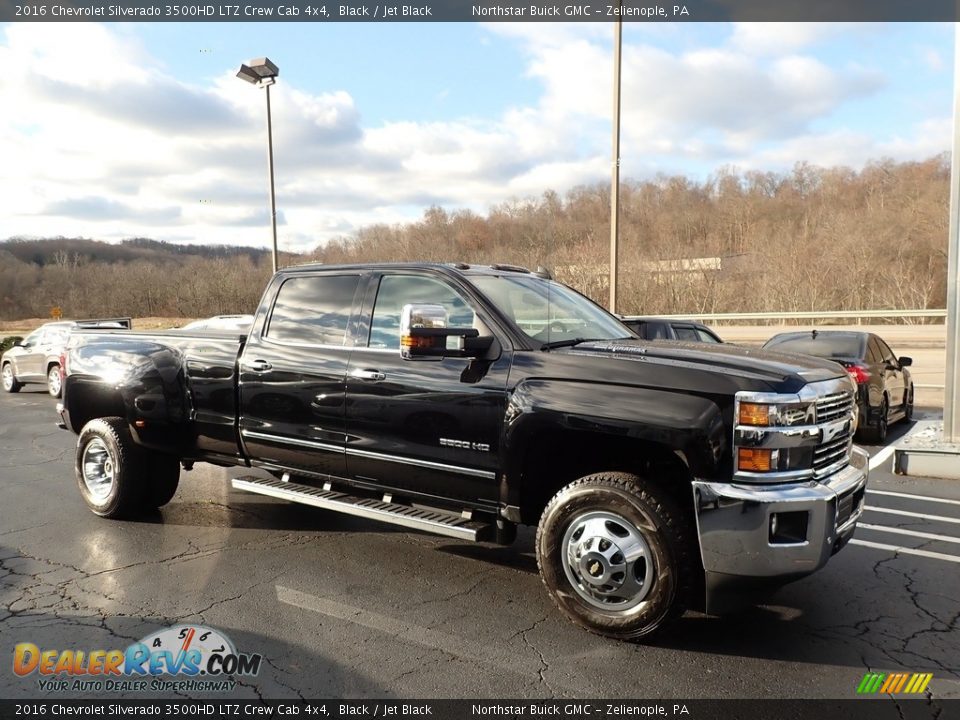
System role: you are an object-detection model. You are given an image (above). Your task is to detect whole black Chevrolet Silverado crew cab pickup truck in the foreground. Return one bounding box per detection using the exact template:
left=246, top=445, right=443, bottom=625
left=58, top=264, right=868, bottom=639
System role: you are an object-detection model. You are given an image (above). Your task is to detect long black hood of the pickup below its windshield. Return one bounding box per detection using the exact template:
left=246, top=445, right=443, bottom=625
left=550, top=340, right=846, bottom=385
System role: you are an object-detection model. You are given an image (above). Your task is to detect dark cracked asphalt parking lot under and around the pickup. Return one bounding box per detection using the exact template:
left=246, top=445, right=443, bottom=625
left=0, top=386, right=960, bottom=701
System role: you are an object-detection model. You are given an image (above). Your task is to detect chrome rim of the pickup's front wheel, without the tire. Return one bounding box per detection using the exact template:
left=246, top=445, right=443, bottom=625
left=563, top=511, right=656, bottom=611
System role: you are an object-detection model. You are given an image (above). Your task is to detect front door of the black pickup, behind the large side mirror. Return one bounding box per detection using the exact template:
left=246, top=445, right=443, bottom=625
left=346, top=271, right=510, bottom=504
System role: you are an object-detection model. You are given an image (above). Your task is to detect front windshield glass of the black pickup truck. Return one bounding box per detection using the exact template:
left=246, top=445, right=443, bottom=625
left=470, top=275, right=632, bottom=343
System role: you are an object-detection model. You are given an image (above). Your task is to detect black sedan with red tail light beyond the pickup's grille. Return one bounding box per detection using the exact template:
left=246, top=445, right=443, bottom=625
left=763, top=330, right=913, bottom=443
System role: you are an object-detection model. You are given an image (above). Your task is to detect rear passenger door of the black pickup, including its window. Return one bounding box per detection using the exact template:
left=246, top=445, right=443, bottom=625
left=239, top=271, right=362, bottom=477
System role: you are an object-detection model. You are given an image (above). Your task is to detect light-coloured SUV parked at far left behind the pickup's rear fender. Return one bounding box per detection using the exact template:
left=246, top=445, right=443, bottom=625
left=0, top=318, right=131, bottom=397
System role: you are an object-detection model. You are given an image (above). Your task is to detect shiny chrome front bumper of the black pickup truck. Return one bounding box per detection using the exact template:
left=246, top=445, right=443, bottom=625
left=693, top=447, right=870, bottom=612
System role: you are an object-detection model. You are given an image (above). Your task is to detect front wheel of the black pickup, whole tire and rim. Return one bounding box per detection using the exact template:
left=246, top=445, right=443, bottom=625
left=536, top=472, right=702, bottom=640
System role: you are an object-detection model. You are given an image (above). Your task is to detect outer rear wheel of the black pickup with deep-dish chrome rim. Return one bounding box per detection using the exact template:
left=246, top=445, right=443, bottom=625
left=76, top=417, right=148, bottom=518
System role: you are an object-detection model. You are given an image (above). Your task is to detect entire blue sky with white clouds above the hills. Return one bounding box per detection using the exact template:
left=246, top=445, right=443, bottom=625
left=0, top=23, right=953, bottom=250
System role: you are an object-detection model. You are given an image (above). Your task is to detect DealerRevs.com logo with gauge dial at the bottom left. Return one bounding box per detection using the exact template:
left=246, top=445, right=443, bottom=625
left=13, top=625, right=263, bottom=692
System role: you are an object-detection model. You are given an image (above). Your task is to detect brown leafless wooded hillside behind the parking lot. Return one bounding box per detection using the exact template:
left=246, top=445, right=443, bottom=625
left=0, top=155, right=949, bottom=319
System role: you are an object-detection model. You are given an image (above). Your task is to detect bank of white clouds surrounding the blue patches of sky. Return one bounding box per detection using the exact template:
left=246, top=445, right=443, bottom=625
left=0, top=23, right=950, bottom=249
